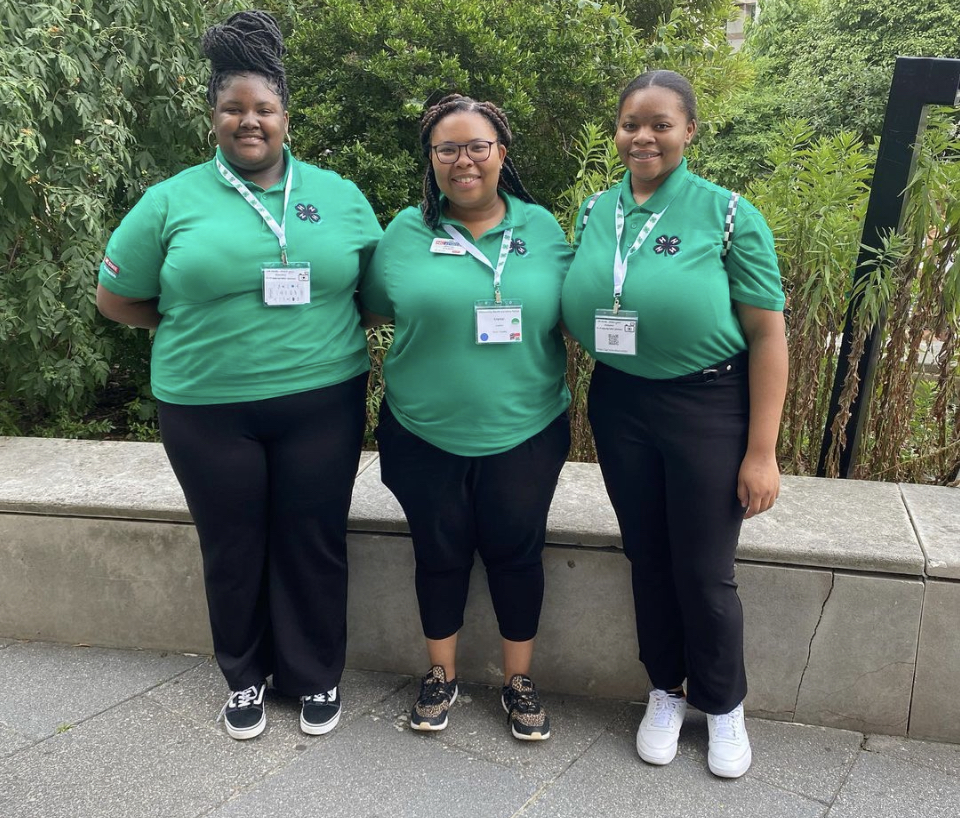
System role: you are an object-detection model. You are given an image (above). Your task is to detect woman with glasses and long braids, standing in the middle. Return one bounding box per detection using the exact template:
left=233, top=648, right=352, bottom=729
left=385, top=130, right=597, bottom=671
left=360, top=94, right=570, bottom=740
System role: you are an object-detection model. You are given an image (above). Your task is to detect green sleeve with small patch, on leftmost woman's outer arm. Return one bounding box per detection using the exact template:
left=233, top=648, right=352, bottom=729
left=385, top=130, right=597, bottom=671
left=98, top=190, right=166, bottom=299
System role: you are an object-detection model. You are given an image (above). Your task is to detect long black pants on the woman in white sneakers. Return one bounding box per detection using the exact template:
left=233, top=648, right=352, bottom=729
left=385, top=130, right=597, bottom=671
left=589, top=363, right=749, bottom=714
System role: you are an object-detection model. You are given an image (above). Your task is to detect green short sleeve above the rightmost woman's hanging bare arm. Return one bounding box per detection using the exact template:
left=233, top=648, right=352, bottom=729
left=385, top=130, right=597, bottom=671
left=725, top=199, right=784, bottom=311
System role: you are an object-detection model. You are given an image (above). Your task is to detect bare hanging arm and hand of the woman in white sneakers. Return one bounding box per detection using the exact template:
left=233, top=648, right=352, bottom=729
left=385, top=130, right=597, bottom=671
left=735, top=302, right=787, bottom=518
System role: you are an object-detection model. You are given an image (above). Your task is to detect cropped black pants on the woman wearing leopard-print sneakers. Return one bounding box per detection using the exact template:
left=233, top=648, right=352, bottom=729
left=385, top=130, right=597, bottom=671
left=377, top=401, right=570, bottom=642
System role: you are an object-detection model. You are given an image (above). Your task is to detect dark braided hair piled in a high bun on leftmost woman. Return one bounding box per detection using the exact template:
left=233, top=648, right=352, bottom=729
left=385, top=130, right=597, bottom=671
left=201, top=11, right=290, bottom=110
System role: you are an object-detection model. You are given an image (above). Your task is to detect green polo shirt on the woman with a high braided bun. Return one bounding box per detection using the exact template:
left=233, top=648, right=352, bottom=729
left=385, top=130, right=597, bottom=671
left=100, top=152, right=383, bottom=404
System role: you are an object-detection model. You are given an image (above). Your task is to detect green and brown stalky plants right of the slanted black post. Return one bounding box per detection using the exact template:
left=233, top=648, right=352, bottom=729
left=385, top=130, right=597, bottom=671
left=842, top=110, right=960, bottom=483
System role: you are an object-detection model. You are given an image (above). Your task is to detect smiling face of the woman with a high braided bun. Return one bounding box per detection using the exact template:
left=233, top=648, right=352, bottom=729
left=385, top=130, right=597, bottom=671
left=211, top=74, right=289, bottom=188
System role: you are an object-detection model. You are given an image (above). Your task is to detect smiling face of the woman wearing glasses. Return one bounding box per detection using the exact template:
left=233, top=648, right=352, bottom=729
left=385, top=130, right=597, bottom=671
left=430, top=111, right=507, bottom=221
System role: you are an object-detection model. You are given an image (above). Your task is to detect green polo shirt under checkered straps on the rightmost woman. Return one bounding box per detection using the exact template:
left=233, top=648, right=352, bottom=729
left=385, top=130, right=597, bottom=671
left=563, top=159, right=784, bottom=379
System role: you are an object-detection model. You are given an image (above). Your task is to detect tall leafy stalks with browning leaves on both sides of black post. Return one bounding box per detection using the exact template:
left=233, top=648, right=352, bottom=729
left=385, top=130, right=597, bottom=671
left=747, top=112, right=960, bottom=482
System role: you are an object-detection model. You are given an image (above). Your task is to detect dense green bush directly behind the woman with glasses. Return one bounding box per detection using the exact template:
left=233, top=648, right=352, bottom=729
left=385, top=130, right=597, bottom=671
left=278, top=0, right=645, bottom=220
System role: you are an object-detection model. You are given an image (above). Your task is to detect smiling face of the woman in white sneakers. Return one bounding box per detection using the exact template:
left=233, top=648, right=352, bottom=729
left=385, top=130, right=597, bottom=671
left=615, top=85, right=697, bottom=200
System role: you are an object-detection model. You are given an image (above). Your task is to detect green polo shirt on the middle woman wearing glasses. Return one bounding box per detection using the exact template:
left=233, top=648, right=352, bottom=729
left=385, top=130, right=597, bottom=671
left=360, top=192, right=572, bottom=457
